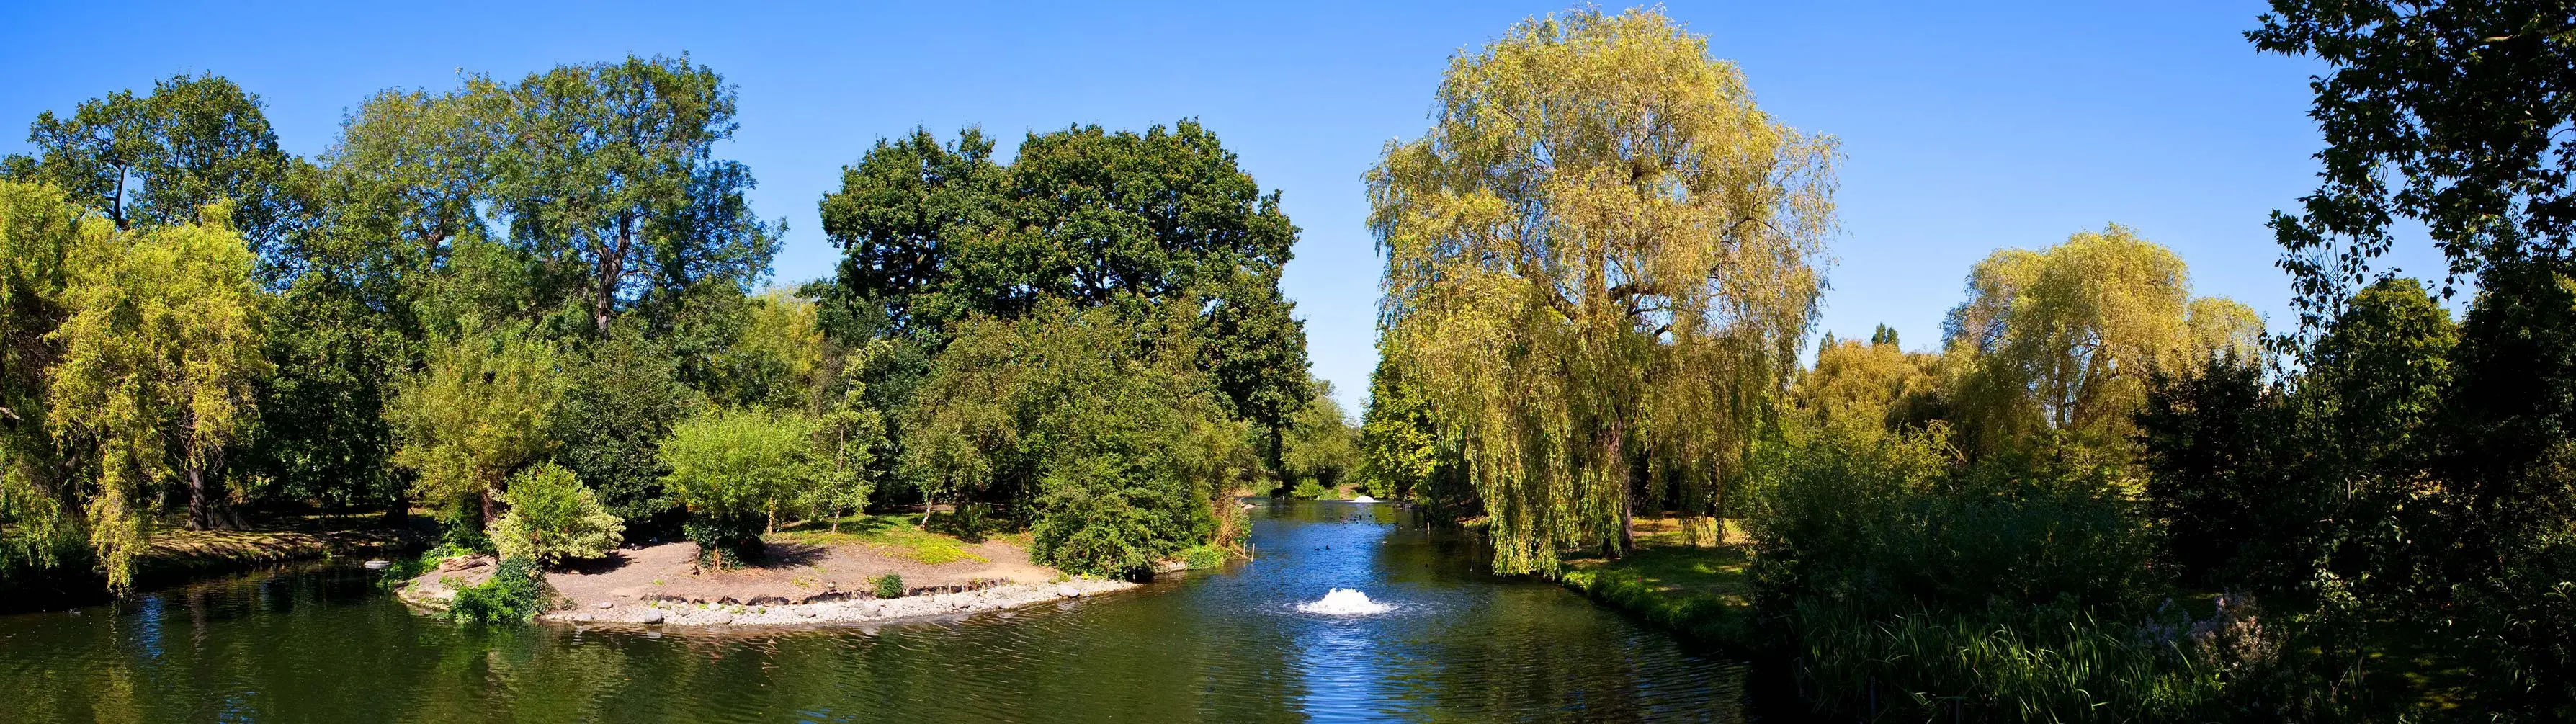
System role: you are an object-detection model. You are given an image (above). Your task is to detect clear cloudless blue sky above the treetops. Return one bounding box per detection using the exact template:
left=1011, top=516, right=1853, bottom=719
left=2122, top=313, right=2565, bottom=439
left=0, top=3, right=2437, bottom=415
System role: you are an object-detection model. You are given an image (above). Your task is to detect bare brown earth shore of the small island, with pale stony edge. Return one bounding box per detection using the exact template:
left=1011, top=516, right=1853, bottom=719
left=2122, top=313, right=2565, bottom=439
left=397, top=515, right=1133, bottom=626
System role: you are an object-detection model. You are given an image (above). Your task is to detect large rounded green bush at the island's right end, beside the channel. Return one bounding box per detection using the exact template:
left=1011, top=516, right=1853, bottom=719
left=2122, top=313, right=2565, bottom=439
left=902, top=304, right=1247, bottom=575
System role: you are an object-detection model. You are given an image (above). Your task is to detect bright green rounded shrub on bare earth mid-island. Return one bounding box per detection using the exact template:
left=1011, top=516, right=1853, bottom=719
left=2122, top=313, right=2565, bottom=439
left=659, top=407, right=814, bottom=567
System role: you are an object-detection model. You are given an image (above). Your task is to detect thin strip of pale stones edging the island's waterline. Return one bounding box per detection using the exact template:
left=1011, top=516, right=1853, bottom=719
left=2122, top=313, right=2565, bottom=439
left=544, top=577, right=1133, bottom=626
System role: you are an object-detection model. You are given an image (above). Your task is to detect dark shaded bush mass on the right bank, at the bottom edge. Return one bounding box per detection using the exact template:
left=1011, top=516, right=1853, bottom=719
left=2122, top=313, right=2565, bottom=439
left=1752, top=430, right=2223, bottom=721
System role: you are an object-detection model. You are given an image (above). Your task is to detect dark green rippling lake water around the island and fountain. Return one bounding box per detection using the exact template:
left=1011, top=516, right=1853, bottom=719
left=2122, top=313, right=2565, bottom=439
left=0, top=502, right=1744, bottom=721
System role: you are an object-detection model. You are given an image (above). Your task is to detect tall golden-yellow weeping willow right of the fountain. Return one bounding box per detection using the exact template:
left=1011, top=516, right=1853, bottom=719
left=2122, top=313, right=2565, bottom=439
left=1368, top=10, right=1837, bottom=572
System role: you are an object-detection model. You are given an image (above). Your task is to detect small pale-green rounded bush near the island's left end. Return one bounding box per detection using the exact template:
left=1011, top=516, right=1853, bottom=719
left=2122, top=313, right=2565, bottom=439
left=492, top=464, right=626, bottom=564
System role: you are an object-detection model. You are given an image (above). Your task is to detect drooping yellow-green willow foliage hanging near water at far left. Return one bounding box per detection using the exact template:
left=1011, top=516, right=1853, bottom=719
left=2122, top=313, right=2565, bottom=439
left=46, top=204, right=270, bottom=590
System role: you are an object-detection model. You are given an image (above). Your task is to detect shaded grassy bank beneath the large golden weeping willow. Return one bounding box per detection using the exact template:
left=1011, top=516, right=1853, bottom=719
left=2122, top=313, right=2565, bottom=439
left=1558, top=518, right=1752, bottom=644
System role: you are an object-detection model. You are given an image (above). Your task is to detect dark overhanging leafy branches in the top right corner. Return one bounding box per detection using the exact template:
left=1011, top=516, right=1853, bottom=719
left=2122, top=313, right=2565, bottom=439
left=2246, top=0, right=2576, bottom=321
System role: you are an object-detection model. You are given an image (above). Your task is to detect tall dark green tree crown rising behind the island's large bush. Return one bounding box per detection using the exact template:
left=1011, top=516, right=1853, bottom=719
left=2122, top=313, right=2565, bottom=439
left=819, top=121, right=1311, bottom=479
